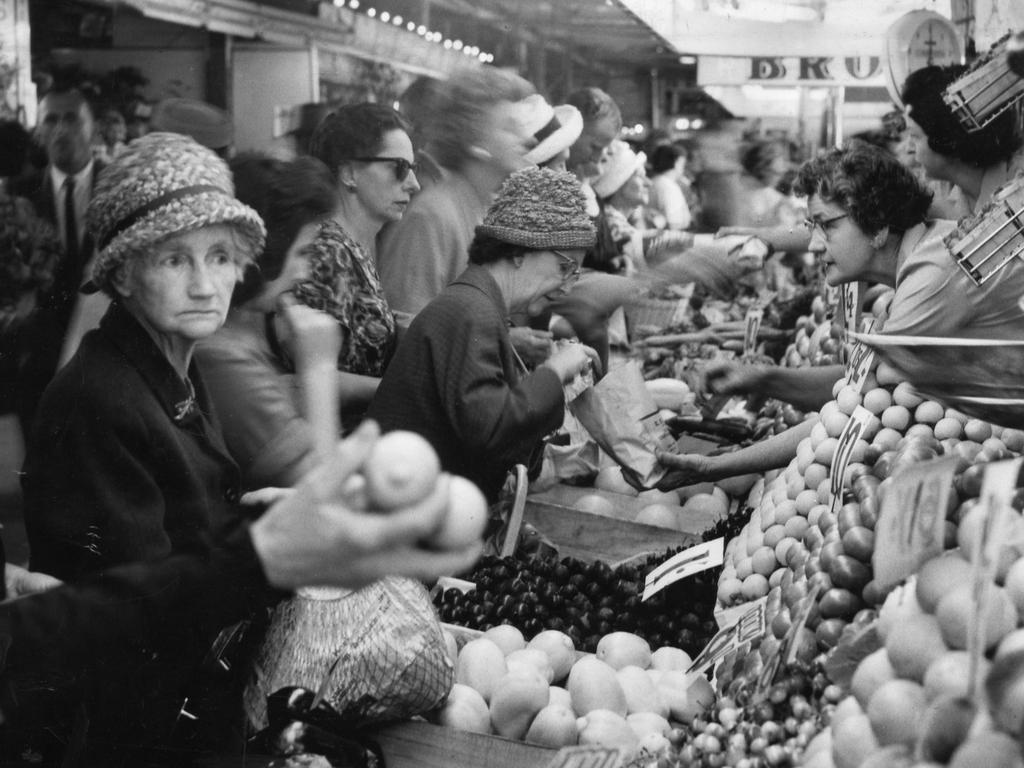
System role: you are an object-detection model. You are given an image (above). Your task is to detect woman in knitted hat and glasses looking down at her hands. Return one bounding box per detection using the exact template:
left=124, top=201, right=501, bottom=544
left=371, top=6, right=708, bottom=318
left=369, top=168, right=599, bottom=500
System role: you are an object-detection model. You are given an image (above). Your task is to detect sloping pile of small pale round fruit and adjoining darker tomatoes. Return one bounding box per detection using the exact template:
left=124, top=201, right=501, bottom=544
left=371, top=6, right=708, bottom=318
left=718, top=364, right=1024, bottom=656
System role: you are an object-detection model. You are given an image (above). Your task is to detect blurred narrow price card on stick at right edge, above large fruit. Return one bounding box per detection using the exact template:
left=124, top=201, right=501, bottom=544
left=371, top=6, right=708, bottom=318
left=967, top=459, right=1024, bottom=700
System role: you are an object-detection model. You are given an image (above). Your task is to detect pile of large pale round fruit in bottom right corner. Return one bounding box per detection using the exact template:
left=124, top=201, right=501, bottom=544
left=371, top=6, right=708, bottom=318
left=803, top=540, right=1024, bottom=768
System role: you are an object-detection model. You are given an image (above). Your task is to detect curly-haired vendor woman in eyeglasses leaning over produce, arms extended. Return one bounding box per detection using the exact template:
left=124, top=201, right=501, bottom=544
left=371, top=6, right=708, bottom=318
left=659, top=143, right=1024, bottom=487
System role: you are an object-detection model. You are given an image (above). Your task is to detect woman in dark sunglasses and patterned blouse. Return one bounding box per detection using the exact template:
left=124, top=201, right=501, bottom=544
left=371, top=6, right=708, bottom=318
left=294, top=103, right=420, bottom=415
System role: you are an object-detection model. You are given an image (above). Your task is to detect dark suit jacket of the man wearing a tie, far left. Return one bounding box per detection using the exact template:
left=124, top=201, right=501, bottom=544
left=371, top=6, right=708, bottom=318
left=14, top=160, right=104, bottom=439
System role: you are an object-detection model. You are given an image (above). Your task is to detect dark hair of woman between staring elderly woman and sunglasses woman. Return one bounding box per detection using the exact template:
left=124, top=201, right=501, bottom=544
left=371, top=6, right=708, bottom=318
left=228, top=153, right=338, bottom=305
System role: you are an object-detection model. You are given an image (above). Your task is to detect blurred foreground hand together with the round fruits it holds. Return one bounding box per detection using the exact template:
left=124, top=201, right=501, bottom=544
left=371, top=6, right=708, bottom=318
left=251, top=422, right=486, bottom=589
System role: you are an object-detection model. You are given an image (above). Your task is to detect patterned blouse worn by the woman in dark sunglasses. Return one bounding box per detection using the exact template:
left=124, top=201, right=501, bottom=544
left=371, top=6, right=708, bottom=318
left=294, top=219, right=397, bottom=377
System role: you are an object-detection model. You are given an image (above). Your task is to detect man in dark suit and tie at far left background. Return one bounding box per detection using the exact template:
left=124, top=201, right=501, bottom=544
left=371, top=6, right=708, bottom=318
left=16, top=89, right=101, bottom=437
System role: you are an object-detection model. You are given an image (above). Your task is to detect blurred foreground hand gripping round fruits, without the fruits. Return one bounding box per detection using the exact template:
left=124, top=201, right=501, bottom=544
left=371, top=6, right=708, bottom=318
left=250, top=421, right=483, bottom=589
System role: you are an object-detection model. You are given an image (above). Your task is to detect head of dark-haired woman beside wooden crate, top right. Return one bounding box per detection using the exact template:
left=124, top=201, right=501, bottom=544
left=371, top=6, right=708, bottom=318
left=902, top=67, right=1021, bottom=219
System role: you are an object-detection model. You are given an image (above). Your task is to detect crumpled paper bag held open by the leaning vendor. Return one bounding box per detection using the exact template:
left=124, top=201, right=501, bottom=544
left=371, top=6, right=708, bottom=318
left=569, top=360, right=674, bottom=488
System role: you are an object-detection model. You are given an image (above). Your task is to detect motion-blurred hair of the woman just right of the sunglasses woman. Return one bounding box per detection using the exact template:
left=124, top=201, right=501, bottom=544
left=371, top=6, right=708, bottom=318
left=427, top=67, right=536, bottom=169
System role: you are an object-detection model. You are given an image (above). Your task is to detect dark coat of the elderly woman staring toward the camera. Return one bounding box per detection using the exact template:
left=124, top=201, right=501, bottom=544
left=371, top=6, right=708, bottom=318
left=22, top=302, right=249, bottom=757
